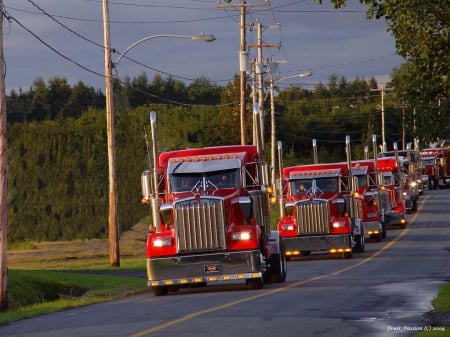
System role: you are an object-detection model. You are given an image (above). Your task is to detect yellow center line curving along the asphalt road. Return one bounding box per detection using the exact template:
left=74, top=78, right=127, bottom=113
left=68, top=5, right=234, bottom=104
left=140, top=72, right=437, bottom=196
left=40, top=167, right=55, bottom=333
left=129, top=197, right=428, bottom=337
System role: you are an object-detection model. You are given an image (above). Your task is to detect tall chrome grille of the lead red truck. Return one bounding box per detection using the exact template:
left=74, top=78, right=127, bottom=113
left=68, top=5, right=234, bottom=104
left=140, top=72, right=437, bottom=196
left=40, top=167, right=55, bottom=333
left=174, top=198, right=226, bottom=254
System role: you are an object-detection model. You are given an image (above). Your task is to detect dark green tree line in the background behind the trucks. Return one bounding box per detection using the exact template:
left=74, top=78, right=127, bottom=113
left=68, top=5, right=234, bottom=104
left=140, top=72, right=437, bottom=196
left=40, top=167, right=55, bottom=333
left=7, top=75, right=448, bottom=242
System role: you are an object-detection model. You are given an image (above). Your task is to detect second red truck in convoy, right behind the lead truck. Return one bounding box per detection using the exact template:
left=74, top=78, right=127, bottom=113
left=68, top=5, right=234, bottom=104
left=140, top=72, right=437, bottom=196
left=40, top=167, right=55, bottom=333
left=278, top=138, right=365, bottom=259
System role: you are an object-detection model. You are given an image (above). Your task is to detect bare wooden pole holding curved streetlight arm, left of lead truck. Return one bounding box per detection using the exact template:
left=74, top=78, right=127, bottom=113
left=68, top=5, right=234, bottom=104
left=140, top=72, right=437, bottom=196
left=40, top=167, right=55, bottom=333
left=103, top=0, right=120, bottom=267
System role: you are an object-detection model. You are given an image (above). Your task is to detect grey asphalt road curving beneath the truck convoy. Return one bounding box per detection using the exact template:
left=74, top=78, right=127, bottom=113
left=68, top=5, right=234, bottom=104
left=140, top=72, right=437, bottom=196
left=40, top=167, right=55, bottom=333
left=0, top=189, right=450, bottom=337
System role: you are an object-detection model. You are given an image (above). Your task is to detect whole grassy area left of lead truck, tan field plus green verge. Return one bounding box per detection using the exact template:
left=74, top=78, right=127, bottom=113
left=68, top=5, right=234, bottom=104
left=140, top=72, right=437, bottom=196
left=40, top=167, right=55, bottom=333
left=0, top=223, right=148, bottom=324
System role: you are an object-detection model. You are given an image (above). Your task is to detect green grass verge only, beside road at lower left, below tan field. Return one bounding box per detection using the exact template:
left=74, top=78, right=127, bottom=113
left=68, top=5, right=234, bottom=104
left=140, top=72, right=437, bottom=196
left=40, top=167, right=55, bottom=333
left=0, top=260, right=148, bottom=324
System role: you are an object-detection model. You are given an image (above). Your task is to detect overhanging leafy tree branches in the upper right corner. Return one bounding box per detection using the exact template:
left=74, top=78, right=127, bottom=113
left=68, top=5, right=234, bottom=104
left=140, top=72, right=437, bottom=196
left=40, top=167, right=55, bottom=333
left=318, top=0, right=450, bottom=144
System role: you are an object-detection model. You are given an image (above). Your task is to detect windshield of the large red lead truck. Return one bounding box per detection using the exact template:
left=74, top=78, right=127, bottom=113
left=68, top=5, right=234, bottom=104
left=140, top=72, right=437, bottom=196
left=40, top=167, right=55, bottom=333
left=170, top=169, right=240, bottom=192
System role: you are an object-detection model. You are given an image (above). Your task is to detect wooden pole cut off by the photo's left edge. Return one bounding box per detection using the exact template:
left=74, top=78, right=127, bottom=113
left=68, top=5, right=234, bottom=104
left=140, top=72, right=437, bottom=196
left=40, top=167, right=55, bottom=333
left=0, top=0, right=8, bottom=311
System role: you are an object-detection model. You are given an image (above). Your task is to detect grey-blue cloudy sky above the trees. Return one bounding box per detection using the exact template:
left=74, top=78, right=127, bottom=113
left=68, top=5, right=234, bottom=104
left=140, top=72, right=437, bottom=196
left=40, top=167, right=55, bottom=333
left=3, top=0, right=403, bottom=94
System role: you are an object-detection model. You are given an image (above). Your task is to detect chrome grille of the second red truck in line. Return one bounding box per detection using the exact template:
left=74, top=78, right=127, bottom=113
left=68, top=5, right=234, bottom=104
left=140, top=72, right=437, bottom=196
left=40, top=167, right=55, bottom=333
left=295, top=201, right=330, bottom=235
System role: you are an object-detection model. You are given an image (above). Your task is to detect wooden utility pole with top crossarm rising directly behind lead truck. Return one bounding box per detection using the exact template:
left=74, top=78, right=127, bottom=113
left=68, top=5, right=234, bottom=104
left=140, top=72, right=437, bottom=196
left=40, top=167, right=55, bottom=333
left=217, top=0, right=269, bottom=145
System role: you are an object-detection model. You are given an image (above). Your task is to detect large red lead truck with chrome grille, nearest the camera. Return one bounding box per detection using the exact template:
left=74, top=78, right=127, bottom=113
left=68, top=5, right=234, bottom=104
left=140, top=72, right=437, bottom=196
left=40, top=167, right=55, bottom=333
left=141, top=112, right=286, bottom=296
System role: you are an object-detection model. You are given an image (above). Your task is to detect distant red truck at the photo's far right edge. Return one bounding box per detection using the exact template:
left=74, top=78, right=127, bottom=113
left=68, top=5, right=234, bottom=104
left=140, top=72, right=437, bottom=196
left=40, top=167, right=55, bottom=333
left=420, top=148, right=450, bottom=189
